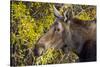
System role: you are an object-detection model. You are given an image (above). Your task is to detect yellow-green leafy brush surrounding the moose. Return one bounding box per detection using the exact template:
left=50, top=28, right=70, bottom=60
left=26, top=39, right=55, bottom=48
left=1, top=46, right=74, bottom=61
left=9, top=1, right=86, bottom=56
left=10, top=1, right=96, bottom=66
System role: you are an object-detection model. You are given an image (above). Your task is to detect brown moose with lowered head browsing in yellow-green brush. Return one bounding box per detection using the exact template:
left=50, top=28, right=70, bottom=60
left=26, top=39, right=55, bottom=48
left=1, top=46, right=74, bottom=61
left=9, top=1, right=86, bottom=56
left=37, top=7, right=96, bottom=62
